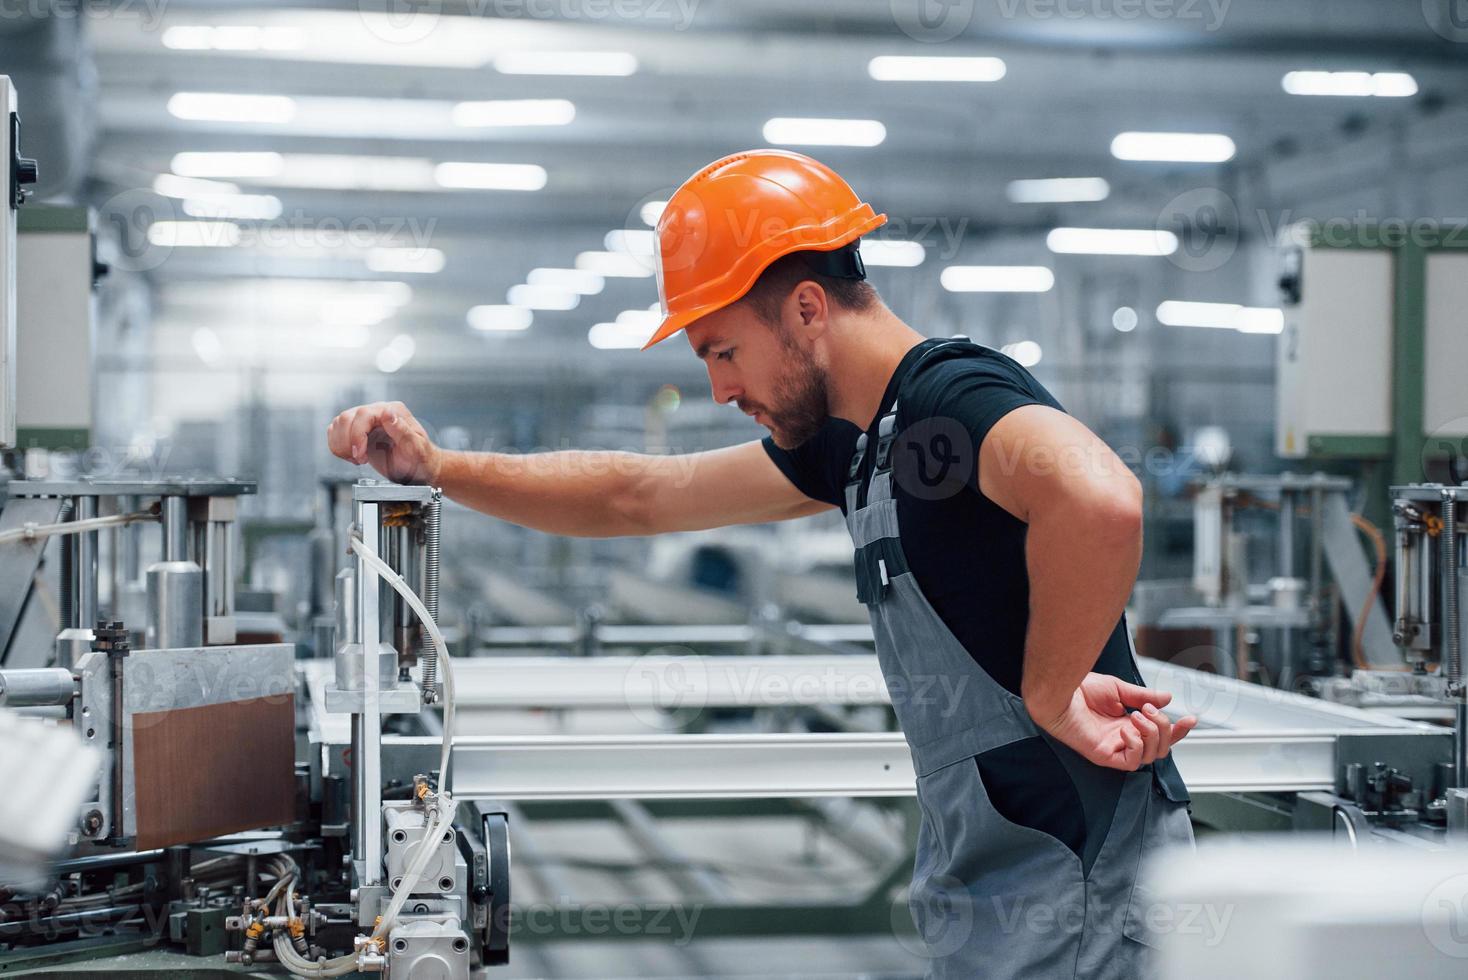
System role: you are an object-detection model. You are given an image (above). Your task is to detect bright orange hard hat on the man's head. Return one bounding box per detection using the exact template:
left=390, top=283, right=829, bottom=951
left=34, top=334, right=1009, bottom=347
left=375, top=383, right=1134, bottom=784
left=643, top=150, right=887, bottom=351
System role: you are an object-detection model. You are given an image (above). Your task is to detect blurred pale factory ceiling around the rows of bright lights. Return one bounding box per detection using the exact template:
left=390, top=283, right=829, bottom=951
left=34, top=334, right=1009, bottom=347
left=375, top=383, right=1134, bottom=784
left=74, top=0, right=1468, bottom=375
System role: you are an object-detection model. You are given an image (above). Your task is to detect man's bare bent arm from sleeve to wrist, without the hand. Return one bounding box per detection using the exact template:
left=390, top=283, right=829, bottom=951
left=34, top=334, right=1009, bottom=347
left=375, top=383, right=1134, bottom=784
left=979, top=405, right=1142, bottom=726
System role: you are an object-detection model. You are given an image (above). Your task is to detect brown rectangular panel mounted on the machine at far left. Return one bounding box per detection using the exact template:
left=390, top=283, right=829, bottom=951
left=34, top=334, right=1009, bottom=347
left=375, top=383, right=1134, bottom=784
left=131, top=695, right=295, bottom=849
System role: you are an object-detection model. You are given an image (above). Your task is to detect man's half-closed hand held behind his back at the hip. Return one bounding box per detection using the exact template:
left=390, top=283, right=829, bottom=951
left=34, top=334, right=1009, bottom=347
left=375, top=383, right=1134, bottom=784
left=1031, top=673, right=1198, bottom=772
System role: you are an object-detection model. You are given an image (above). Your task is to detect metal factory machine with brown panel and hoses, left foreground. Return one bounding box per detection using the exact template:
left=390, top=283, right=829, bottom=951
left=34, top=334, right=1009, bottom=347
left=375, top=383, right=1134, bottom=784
left=0, top=480, right=509, bottom=979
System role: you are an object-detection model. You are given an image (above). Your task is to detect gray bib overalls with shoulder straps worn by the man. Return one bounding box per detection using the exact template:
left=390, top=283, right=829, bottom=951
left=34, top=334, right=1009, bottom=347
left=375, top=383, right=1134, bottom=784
left=846, top=348, right=1192, bottom=980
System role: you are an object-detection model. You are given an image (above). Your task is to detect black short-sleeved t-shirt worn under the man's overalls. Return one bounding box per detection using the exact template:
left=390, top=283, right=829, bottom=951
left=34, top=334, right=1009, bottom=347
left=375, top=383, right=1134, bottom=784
left=763, top=340, right=1133, bottom=695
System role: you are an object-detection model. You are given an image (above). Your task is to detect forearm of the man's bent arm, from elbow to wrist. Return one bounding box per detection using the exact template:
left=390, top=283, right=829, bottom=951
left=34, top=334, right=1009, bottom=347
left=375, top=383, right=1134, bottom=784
left=1022, top=494, right=1142, bottom=725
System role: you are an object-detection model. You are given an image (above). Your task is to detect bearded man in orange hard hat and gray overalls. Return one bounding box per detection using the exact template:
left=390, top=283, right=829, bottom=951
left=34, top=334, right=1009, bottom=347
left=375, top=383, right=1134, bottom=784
left=329, top=150, right=1196, bottom=980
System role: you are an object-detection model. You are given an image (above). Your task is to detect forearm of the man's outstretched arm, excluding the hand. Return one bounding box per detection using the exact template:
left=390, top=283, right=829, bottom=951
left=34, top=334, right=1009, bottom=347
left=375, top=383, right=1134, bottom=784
left=435, top=450, right=675, bottom=537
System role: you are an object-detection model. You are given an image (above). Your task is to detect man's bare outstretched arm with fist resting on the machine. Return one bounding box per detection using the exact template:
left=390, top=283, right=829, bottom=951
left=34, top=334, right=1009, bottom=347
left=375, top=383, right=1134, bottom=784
left=327, top=402, right=829, bottom=537
